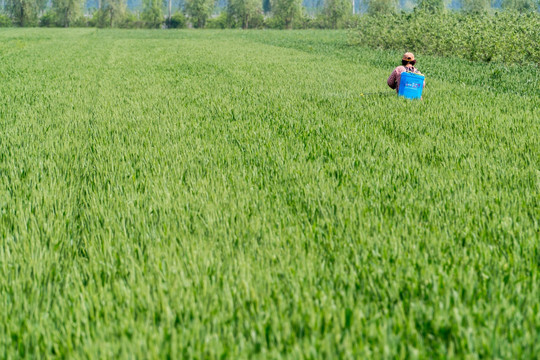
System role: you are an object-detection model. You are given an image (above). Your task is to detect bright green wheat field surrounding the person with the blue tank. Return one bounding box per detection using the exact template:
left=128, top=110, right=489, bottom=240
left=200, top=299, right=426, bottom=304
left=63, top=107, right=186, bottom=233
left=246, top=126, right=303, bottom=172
left=0, top=29, right=540, bottom=359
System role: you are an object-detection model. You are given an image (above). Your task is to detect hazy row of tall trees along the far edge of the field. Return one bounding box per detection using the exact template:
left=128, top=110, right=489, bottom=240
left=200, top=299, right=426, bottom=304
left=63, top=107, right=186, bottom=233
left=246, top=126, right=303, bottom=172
left=0, top=0, right=540, bottom=29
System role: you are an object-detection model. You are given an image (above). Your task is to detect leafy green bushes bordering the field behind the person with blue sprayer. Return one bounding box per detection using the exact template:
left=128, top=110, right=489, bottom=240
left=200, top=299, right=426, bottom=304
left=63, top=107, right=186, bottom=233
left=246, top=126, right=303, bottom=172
left=351, top=11, right=540, bottom=64
